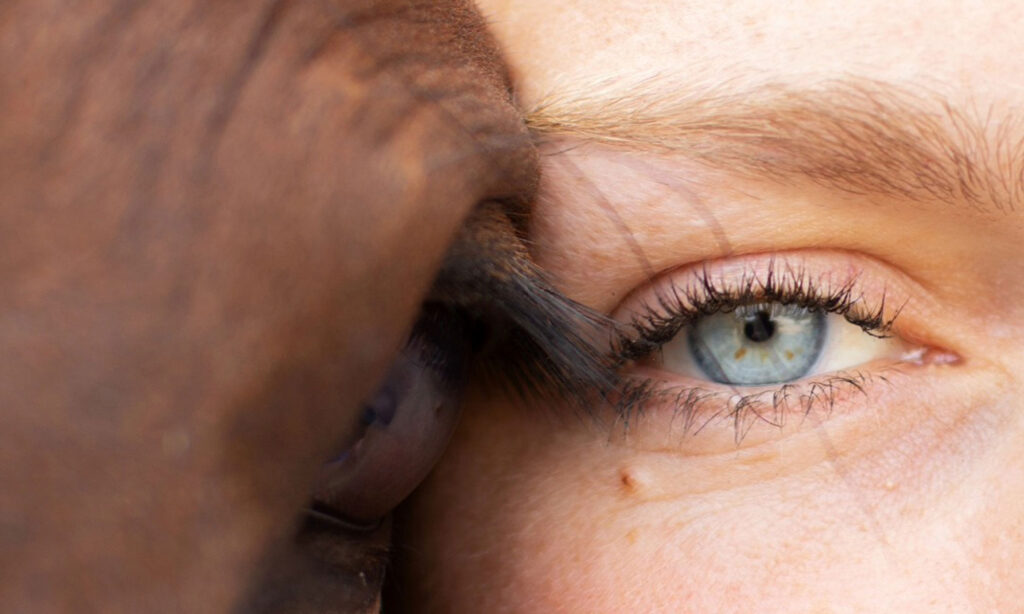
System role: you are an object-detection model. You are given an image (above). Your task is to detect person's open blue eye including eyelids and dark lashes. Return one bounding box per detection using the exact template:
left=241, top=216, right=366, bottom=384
left=602, top=254, right=956, bottom=445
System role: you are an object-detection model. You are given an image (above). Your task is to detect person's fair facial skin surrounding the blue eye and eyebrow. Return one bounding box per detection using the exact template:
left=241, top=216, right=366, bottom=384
left=400, top=0, right=1024, bottom=613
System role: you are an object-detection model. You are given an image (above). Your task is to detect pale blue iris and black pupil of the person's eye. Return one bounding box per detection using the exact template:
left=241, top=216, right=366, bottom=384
left=687, top=303, right=826, bottom=386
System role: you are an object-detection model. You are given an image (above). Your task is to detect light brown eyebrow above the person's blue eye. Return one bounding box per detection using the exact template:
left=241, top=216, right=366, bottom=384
left=527, top=79, right=1024, bottom=212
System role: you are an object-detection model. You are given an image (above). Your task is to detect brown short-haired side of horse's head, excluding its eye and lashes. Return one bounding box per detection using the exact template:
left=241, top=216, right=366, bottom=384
left=0, top=0, right=536, bottom=611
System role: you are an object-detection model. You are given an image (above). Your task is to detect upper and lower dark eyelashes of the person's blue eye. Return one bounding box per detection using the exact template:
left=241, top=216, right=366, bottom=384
left=612, top=264, right=902, bottom=444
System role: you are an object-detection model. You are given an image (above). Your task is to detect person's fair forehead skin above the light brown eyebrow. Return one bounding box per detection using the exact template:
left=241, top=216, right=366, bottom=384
left=478, top=0, right=1024, bottom=106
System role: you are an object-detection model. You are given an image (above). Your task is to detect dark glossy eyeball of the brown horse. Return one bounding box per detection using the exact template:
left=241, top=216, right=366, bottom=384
left=311, top=309, right=468, bottom=527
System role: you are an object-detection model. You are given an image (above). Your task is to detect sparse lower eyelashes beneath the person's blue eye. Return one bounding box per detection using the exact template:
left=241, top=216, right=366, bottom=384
left=613, top=370, right=890, bottom=445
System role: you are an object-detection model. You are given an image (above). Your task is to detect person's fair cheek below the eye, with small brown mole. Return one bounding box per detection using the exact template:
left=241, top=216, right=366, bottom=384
left=401, top=388, right=1024, bottom=613
